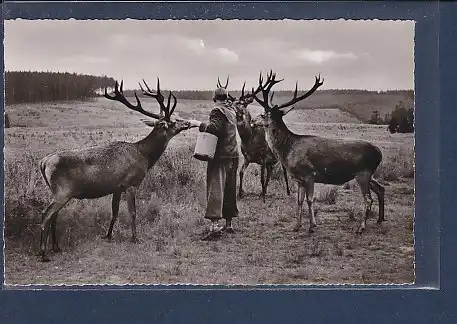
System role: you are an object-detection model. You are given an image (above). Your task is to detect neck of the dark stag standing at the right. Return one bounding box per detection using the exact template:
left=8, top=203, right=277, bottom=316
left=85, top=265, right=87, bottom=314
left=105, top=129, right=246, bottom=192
left=265, top=117, right=296, bottom=159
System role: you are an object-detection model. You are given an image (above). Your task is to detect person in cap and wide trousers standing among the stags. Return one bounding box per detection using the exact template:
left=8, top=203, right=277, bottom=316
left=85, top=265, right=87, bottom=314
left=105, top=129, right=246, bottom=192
left=199, top=87, right=238, bottom=240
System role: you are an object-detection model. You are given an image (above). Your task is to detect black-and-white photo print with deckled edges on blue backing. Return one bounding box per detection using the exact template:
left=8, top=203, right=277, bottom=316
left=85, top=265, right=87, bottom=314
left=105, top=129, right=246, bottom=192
left=3, top=19, right=415, bottom=288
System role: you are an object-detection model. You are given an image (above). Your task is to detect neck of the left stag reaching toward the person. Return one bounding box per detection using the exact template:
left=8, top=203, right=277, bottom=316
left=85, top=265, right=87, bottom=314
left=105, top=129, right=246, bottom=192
left=136, top=127, right=173, bottom=169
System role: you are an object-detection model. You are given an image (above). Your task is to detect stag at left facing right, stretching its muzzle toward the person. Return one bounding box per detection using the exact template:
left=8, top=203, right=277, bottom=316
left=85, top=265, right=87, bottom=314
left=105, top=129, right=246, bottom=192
left=40, top=79, right=200, bottom=261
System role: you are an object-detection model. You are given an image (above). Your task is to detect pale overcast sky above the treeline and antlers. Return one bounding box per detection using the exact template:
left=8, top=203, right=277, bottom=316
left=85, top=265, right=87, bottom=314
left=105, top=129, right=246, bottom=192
left=5, top=19, right=414, bottom=90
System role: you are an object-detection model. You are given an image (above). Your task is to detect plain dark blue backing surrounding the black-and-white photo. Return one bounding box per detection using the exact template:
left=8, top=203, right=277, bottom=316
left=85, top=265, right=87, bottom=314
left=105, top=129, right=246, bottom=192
left=0, top=2, right=457, bottom=323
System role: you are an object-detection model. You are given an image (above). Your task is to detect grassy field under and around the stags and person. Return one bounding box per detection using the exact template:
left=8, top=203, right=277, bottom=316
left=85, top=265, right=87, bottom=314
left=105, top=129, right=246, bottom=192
left=4, top=99, right=414, bottom=285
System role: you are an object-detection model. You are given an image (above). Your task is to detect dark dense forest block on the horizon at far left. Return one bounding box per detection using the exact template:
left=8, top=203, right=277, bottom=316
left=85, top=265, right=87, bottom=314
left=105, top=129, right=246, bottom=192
left=5, top=71, right=115, bottom=104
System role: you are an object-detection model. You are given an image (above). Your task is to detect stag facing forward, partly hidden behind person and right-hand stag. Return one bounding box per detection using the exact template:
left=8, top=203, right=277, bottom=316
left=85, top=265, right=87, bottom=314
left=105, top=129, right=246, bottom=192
left=234, top=76, right=290, bottom=202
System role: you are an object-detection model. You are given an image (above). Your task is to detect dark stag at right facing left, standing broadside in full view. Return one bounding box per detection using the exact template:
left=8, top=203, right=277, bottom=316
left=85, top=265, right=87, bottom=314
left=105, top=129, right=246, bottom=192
left=252, top=71, right=384, bottom=234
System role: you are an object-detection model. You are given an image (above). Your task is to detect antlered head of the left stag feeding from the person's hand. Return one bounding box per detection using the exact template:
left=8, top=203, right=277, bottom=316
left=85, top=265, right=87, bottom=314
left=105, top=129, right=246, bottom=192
left=104, top=78, right=200, bottom=136
